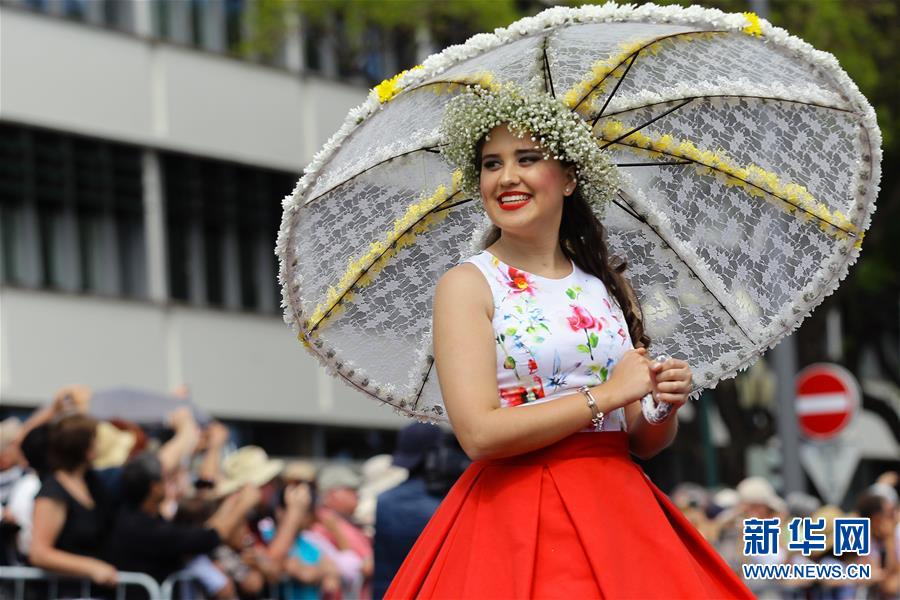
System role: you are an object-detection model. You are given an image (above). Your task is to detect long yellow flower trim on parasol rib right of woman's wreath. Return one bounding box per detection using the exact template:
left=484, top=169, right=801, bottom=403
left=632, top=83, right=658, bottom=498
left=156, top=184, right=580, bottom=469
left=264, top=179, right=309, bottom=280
left=597, top=119, right=863, bottom=248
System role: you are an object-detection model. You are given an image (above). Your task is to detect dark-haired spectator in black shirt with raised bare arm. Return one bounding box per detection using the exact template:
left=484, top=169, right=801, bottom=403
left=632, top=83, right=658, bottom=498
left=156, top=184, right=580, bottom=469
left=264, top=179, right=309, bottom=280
left=107, top=454, right=259, bottom=581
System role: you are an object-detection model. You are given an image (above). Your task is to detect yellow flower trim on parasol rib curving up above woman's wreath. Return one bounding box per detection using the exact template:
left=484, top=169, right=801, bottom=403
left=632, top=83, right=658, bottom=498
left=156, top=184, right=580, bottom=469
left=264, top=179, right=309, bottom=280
left=563, top=31, right=722, bottom=115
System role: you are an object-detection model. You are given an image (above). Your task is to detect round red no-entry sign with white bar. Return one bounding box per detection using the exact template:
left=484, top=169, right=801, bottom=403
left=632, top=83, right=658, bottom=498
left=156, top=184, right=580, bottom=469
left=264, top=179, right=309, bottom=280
left=796, top=363, right=859, bottom=440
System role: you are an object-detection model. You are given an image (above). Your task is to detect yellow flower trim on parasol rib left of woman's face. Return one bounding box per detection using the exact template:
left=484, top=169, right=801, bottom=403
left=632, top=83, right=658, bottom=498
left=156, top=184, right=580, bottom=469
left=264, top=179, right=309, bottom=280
left=297, top=171, right=462, bottom=343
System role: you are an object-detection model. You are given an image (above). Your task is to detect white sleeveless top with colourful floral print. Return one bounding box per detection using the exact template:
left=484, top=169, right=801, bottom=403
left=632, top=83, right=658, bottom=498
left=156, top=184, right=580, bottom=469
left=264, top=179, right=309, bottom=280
left=465, top=250, right=632, bottom=431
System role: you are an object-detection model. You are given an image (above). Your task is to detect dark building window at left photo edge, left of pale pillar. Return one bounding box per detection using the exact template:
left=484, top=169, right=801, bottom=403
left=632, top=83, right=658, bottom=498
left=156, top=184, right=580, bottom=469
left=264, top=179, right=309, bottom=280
left=0, top=123, right=147, bottom=298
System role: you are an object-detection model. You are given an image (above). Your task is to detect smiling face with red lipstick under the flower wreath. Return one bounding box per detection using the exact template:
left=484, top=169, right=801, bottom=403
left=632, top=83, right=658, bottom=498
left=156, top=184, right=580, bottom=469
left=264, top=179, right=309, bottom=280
left=480, top=125, right=575, bottom=233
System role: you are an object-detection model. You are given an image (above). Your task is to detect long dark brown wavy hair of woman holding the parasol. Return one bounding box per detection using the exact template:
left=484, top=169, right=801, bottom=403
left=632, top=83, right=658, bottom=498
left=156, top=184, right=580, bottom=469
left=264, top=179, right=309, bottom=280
left=475, top=139, right=651, bottom=348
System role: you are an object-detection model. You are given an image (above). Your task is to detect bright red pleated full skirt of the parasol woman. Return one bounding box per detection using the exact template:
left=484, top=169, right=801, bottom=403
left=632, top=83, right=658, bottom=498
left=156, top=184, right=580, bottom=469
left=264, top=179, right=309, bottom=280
left=385, top=432, right=753, bottom=600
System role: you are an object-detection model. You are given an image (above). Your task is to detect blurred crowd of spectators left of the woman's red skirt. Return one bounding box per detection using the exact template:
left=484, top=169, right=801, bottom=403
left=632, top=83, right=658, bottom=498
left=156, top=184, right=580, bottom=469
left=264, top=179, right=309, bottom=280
left=0, top=386, right=467, bottom=600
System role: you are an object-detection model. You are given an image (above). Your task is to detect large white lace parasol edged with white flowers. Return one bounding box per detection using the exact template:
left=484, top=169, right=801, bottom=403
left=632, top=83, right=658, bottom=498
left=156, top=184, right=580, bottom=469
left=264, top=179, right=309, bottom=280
left=276, top=4, right=881, bottom=420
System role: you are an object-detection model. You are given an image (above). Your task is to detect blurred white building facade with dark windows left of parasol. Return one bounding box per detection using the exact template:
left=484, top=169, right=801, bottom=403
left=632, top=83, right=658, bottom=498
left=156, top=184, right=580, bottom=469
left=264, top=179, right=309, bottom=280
left=0, top=0, right=418, bottom=450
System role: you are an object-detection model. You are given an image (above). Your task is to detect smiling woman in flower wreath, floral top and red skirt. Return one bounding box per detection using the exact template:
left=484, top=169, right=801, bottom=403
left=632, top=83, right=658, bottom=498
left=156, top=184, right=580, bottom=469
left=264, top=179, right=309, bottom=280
left=386, top=88, right=750, bottom=598
